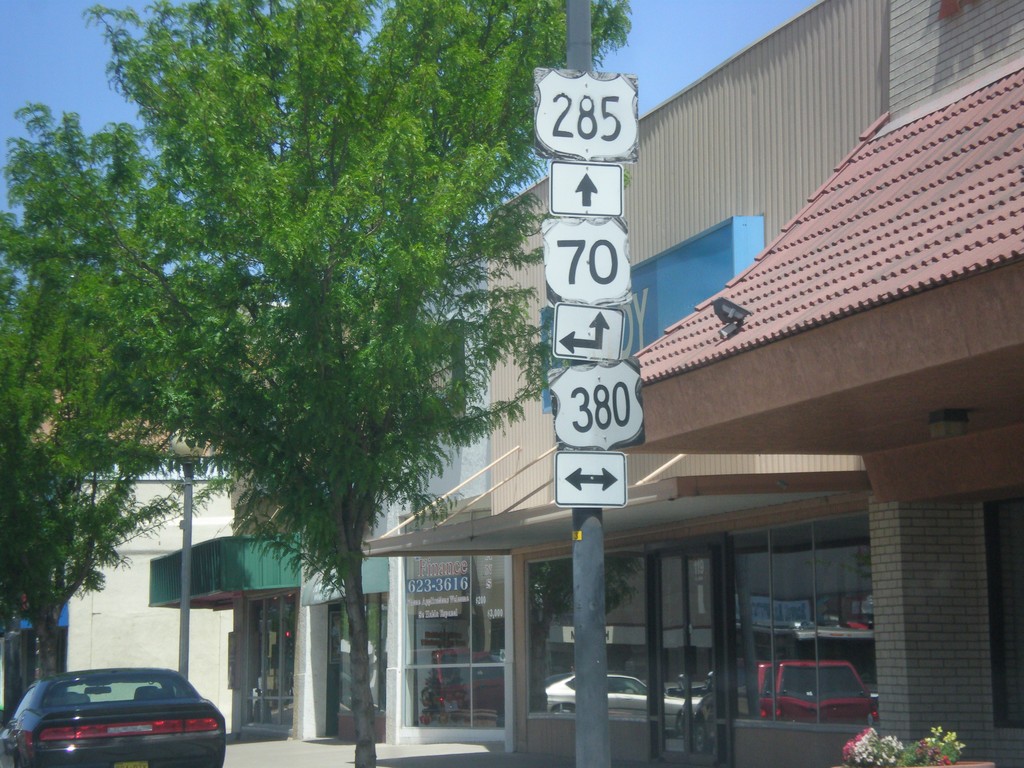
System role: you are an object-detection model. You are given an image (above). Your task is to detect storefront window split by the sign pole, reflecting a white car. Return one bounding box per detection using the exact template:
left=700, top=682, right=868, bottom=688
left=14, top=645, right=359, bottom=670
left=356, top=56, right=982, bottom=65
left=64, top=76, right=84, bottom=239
left=527, top=553, right=649, bottom=718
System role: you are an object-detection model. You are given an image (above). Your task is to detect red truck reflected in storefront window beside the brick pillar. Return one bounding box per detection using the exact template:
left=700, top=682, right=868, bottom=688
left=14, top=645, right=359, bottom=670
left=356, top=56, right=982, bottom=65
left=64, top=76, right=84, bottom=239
left=758, top=659, right=879, bottom=723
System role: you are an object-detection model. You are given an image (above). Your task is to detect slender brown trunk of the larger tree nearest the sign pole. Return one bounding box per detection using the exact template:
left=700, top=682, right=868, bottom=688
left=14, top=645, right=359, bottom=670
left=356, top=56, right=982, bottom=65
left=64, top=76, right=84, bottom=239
left=344, top=557, right=377, bottom=768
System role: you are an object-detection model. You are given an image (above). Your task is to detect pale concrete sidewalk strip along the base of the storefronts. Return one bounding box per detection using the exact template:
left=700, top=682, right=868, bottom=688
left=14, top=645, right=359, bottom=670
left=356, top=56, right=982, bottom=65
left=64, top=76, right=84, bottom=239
left=224, top=739, right=647, bottom=768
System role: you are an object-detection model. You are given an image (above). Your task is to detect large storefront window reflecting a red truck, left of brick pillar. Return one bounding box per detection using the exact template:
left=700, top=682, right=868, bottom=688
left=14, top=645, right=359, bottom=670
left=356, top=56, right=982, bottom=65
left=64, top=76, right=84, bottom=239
left=733, top=516, right=878, bottom=723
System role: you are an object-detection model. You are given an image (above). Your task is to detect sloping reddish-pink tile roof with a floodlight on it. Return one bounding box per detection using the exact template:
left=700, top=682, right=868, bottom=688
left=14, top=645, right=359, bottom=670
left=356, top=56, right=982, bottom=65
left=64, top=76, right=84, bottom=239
left=638, top=64, right=1024, bottom=381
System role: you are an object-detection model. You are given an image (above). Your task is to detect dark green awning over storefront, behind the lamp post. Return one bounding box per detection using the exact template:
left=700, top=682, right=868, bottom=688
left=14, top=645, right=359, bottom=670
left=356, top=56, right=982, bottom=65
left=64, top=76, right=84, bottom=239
left=150, top=536, right=301, bottom=608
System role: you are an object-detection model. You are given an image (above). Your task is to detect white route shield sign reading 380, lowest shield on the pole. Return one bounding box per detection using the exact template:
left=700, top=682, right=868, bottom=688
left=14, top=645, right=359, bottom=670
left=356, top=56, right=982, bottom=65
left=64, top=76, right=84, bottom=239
left=548, top=357, right=644, bottom=451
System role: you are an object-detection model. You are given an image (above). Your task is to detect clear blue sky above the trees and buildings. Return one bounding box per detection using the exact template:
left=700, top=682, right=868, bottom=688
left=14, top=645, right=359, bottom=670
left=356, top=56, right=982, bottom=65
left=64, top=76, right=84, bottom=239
left=0, top=0, right=816, bottom=204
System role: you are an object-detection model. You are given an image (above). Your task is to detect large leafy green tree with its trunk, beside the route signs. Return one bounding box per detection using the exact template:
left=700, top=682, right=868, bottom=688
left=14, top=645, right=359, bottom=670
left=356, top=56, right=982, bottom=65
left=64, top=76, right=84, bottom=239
left=79, top=0, right=628, bottom=766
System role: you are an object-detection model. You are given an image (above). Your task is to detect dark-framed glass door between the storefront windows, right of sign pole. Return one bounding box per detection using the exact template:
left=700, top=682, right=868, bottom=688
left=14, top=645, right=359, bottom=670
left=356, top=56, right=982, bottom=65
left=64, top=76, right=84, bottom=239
left=658, top=551, right=718, bottom=763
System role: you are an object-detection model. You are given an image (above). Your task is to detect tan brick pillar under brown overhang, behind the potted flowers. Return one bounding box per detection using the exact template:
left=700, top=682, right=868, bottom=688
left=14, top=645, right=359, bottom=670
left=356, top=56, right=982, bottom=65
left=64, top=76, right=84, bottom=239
left=870, top=503, right=1024, bottom=768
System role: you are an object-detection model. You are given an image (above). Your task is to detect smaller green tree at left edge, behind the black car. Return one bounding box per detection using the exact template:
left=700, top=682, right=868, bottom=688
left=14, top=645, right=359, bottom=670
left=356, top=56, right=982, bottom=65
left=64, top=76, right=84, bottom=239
left=0, top=108, right=174, bottom=674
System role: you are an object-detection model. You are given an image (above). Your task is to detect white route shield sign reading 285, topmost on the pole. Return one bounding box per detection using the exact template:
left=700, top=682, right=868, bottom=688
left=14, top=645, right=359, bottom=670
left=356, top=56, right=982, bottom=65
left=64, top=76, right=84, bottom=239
left=534, top=69, right=639, bottom=163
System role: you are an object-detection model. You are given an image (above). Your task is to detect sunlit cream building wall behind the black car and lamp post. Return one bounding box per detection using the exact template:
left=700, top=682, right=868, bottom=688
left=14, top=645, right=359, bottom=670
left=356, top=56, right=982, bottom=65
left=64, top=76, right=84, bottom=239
left=68, top=481, right=232, bottom=723
